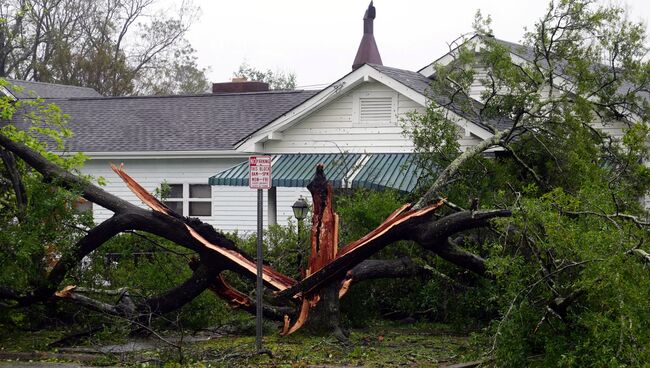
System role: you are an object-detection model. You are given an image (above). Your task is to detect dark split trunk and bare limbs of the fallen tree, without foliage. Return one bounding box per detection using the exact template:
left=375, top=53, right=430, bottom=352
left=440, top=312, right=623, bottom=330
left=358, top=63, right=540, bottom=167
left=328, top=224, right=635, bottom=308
left=0, top=136, right=510, bottom=333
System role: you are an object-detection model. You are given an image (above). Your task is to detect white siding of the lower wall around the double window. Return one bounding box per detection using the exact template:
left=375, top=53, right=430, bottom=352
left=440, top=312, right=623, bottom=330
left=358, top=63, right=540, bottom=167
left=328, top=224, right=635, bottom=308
left=82, top=157, right=310, bottom=232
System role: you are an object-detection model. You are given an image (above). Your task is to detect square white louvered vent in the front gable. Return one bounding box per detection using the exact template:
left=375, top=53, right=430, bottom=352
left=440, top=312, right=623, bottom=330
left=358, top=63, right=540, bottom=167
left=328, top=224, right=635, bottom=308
left=352, top=91, right=397, bottom=126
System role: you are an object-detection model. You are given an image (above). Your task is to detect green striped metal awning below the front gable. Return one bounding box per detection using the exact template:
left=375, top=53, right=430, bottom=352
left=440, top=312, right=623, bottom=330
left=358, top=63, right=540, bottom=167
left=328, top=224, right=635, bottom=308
left=209, top=153, right=420, bottom=192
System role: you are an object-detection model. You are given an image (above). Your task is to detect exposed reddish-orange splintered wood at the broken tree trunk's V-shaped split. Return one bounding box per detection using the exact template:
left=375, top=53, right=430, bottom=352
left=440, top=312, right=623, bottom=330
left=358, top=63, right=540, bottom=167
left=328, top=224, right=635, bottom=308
left=112, top=164, right=443, bottom=335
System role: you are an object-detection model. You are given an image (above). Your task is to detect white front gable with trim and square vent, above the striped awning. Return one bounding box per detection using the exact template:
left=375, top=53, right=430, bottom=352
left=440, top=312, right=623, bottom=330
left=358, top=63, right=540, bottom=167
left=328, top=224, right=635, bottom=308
left=237, top=64, right=491, bottom=153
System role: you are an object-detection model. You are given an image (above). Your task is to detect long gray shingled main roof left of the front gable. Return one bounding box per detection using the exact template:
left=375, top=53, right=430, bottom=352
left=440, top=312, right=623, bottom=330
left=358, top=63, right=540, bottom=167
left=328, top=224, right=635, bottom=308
left=34, top=91, right=317, bottom=152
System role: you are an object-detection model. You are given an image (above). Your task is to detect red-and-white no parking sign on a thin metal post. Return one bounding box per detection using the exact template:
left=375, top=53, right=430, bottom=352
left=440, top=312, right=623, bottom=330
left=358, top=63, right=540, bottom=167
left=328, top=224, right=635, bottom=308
left=248, top=156, right=271, bottom=353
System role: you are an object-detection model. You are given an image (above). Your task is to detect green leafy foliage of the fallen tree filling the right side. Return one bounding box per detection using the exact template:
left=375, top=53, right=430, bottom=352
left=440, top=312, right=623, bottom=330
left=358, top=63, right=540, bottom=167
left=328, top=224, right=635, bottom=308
left=410, top=0, right=650, bottom=366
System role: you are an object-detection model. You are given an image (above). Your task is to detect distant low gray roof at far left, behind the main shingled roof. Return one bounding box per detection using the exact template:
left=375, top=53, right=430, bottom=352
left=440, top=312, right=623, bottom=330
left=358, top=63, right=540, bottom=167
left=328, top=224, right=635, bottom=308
left=6, top=79, right=102, bottom=100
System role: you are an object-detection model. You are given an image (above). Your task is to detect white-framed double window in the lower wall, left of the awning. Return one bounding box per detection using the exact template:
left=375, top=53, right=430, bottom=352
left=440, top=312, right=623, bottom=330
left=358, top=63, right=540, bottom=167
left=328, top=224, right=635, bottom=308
left=165, top=184, right=212, bottom=217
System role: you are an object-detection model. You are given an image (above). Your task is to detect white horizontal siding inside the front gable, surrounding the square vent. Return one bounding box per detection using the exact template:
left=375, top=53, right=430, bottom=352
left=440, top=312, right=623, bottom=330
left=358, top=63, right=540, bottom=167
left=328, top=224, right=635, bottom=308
left=264, top=82, right=480, bottom=153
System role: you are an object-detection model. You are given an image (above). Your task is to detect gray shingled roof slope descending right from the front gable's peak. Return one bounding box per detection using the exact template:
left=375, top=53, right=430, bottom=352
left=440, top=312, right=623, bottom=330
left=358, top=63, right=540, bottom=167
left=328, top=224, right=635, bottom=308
left=368, top=64, right=512, bottom=132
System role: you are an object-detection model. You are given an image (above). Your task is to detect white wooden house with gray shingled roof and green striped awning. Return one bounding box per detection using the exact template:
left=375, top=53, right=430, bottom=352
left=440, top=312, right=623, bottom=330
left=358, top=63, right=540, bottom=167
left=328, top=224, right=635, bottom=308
left=5, top=2, right=632, bottom=231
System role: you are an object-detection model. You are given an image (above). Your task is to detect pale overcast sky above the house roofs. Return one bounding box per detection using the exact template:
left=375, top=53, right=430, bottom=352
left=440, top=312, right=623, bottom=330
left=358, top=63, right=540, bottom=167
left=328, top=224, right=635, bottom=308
left=182, top=0, right=650, bottom=88
